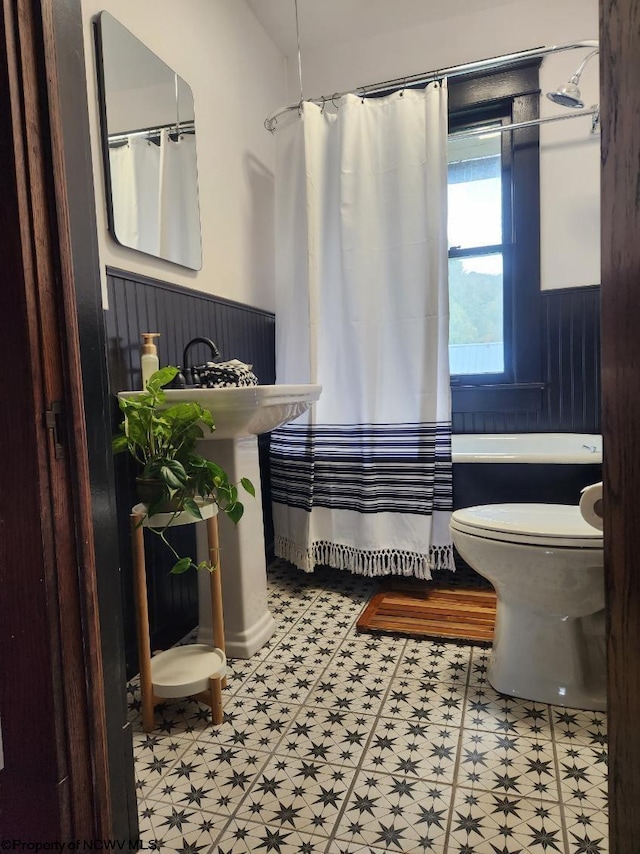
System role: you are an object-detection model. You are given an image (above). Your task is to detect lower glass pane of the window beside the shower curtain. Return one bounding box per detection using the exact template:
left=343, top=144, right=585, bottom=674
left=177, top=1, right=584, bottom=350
left=449, top=253, right=504, bottom=374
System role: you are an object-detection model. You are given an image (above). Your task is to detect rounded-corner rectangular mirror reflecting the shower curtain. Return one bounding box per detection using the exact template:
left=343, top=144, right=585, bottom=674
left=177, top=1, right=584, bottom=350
left=96, top=12, right=202, bottom=270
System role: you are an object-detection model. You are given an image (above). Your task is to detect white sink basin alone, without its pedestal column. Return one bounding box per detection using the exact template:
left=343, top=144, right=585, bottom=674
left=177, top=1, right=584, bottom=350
left=118, top=385, right=322, bottom=440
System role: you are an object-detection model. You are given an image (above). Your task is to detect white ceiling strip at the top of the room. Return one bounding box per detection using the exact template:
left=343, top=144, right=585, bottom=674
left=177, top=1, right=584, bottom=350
left=246, top=0, right=513, bottom=57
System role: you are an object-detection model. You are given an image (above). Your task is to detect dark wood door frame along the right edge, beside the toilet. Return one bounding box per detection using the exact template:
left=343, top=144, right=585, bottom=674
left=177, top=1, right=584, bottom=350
left=600, top=0, right=640, bottom=854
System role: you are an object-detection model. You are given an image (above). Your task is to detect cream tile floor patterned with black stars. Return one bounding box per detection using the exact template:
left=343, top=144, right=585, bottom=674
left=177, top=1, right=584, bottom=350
left=129, top=562, right=608, bottom=854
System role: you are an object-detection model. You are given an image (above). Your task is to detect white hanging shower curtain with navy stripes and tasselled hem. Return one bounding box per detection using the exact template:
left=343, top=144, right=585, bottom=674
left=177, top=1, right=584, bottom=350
left=271, top=84, right=453, bottom=578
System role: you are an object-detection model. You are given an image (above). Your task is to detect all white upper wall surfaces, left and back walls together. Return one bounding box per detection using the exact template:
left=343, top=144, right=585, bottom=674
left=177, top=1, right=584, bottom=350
left=82, top=0, right=600, bottom=309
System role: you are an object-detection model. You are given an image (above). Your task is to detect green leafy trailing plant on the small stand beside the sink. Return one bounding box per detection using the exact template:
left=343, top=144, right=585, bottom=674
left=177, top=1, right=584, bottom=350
left=113, top=366, right=255, bottom=575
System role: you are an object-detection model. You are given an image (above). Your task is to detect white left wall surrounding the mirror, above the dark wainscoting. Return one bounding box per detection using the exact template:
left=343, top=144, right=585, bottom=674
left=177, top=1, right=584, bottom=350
left=82, top=0, right=286, bottom=310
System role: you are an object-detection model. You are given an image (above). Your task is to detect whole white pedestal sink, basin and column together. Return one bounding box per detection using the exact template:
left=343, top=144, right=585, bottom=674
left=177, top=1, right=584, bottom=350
left=118, top=385, right=322, bottom=658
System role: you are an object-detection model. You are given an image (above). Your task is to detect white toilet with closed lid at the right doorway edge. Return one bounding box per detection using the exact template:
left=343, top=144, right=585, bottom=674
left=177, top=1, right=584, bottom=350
left=450, top=504, right=606, bottom=710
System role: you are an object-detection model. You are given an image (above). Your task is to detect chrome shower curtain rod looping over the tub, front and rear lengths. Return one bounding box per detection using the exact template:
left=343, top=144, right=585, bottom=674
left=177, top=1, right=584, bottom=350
left=264, top=39, right=599, bottom=136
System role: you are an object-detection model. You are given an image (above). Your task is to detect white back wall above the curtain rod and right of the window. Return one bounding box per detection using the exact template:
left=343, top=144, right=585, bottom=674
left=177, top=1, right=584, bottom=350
left=282, top=0, right=600, bottom=289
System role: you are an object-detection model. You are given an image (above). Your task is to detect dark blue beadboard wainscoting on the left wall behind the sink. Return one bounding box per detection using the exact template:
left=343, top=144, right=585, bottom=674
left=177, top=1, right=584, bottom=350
left=105, top=269, right=275, bottom=676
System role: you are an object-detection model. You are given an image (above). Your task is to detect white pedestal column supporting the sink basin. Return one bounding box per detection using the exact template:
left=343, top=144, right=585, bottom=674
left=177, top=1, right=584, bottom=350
left=196, top=436, right=276, bottom=658
